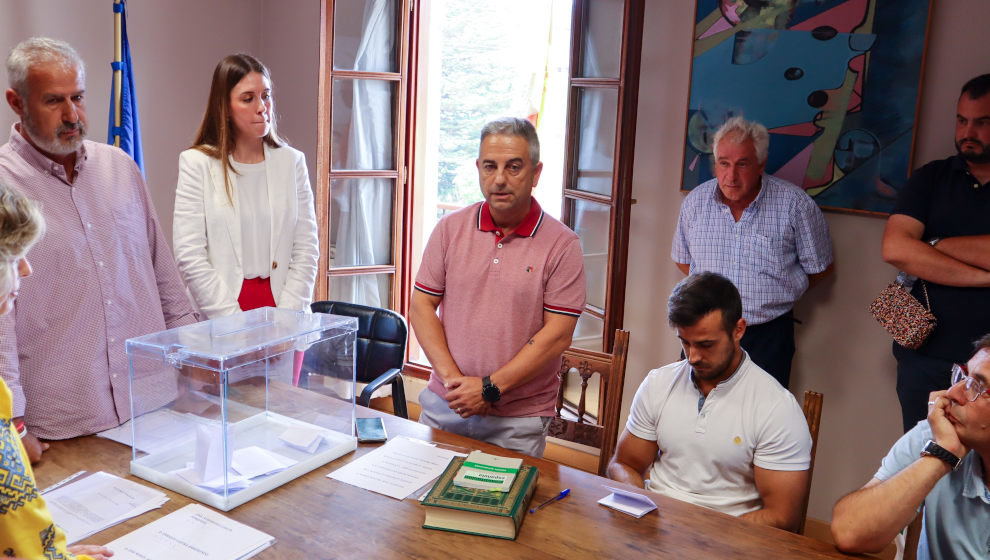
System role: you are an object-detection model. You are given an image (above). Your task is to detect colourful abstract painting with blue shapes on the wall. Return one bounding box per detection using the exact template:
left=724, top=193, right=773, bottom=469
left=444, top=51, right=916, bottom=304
left=681, top=0, right=931, bottom=214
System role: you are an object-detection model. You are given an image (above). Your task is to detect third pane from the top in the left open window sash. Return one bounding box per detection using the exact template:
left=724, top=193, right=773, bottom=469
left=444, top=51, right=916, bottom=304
left=330, top=178, right=395, bottom=269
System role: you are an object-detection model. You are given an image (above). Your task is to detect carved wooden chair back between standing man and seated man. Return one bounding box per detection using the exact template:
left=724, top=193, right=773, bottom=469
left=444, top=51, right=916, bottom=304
left=547, top=330, right=629, bottom=476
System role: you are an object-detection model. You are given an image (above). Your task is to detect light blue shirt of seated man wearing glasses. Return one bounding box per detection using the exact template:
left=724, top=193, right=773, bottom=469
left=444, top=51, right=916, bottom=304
left=874, top=420, right=990, bottom=560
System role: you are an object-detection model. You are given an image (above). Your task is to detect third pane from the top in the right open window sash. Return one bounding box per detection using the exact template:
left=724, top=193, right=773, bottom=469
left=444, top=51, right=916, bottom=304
left=571, top=200, right=611, bottom=309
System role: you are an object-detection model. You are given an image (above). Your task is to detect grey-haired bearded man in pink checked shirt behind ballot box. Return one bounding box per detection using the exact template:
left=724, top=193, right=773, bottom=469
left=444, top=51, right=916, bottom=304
left=0, top=37, right=196, bottom=462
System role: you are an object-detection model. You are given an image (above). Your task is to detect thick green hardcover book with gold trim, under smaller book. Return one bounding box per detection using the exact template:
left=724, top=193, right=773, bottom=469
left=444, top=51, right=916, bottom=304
left=423, top=457, right=540, bottom=540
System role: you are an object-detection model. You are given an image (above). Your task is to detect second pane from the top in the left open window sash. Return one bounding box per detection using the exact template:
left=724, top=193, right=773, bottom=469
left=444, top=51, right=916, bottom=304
left=330, top=79, right=398, bottom=170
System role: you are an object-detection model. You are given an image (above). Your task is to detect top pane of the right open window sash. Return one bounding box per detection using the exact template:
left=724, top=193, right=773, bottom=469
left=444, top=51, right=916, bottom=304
left=578, top=0, right=625, bottom=78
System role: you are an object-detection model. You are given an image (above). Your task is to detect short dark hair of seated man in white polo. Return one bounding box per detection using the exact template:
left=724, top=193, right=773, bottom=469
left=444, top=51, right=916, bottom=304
left=667, top=272, right=742, bottom=333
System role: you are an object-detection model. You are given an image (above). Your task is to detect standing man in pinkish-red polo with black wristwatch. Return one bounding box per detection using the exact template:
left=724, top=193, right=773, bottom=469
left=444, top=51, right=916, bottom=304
left=410, top=118, right=585, bottom=457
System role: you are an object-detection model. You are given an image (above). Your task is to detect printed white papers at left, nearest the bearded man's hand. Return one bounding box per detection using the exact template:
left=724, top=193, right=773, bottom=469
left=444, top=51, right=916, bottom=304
left=45, top=471, right=168, bottom=544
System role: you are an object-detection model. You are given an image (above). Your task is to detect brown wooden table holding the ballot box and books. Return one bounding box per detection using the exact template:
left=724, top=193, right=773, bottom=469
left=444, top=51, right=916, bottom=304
left=35, top=400, right=847, bottom=560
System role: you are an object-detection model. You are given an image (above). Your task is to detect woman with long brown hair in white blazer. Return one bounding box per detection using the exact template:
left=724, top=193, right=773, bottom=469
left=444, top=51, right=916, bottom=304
left=172, top=54, right=319, bottom=318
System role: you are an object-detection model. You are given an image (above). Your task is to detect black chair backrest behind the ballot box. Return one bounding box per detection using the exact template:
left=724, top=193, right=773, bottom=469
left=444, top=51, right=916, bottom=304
left=310, top=301, right=409, bottom=383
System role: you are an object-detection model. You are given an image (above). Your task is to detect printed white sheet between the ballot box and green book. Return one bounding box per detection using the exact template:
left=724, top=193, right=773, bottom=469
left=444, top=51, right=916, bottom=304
left=327, top=436, right=464, bottom=500
